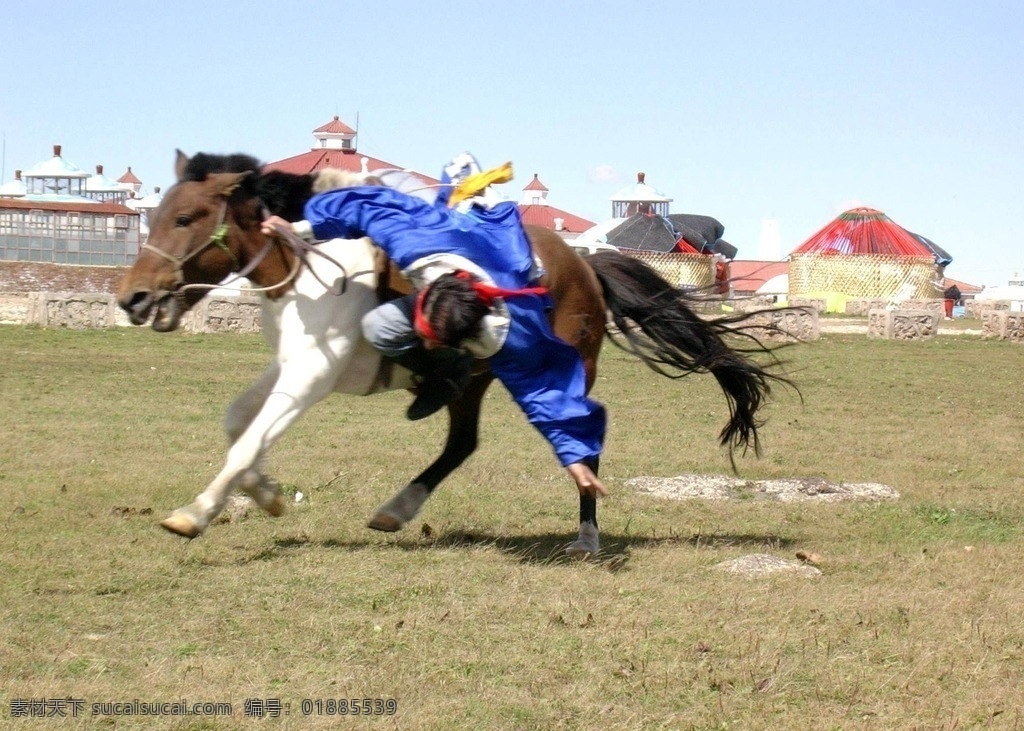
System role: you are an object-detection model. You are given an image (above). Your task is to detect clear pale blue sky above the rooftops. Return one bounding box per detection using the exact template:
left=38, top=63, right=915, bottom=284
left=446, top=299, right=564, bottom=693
left=0, top=0, right=1024, bottom=285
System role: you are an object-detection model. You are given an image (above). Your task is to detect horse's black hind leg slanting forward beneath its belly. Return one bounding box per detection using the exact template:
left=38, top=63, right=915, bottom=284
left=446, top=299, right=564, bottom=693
left=367, top=373, right=494, bottom=532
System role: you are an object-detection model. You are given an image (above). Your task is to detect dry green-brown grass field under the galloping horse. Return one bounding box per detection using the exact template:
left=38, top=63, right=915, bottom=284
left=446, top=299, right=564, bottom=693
left=0, top=327, right=1024, bottom=731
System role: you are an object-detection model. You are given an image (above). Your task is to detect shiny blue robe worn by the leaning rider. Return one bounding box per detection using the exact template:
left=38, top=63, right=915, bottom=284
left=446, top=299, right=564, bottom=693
left=304, top=186, right=606, bottom=467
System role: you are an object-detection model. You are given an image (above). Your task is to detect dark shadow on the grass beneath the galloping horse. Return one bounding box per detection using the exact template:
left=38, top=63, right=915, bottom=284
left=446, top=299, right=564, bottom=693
left=237, top=528, right=796, bottom=571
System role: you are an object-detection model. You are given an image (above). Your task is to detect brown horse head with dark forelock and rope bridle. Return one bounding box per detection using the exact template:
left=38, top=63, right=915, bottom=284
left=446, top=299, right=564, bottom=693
left=118, top=149, right=265, bottom=332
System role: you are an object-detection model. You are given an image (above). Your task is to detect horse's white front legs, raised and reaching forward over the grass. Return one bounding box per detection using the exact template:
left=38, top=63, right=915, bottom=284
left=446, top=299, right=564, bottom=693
left=161, top=352, right=339, bottom=539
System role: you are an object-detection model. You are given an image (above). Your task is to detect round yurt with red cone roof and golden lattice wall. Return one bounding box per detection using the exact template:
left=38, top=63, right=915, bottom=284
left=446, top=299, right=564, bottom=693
left=790, top=208, right=950, bottom=301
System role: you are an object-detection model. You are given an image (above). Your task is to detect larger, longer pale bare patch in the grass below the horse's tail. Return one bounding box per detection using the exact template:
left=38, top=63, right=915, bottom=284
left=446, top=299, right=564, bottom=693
left=626, top=474, right=899, bottom=503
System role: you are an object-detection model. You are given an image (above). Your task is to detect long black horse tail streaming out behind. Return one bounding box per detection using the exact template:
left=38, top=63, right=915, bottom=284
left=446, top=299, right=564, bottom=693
left=586, top=252, right=799, bottom=454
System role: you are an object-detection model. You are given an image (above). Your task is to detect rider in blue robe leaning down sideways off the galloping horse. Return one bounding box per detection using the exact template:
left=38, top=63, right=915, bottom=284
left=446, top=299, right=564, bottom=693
left=263, top=155, right=607, bottom=554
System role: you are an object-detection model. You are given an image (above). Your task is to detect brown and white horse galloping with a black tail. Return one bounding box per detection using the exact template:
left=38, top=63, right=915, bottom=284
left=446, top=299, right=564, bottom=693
left=118, top=149, right=793, bottom=556
